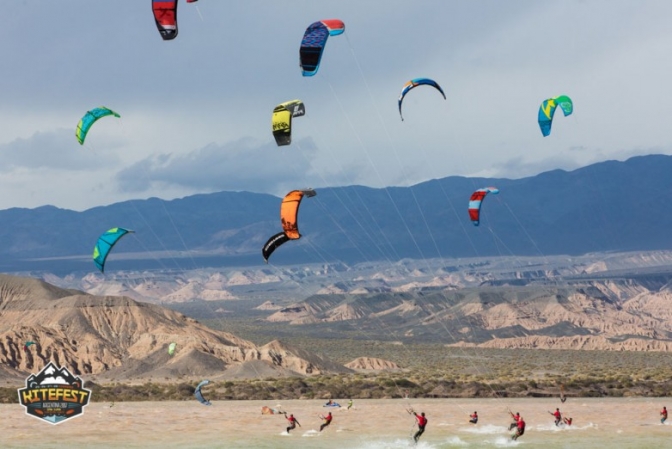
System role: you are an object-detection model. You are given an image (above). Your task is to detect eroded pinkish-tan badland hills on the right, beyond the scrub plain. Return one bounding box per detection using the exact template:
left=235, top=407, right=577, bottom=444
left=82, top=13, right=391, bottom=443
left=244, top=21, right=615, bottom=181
left=267, top=274, right=672, bottom=351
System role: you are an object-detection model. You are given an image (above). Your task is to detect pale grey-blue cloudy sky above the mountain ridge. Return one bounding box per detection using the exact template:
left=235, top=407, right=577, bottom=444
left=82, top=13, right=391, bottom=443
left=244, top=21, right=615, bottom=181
left=0, top=0, right=672, bottom=210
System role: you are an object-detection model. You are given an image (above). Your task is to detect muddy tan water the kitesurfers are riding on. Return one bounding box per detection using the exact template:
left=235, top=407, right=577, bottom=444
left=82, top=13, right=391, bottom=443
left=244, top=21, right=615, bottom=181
left=0, top=398, right=672, bottom=449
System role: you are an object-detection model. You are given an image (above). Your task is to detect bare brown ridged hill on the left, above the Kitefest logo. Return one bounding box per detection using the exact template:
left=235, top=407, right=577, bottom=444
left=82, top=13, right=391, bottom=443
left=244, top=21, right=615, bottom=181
left=0, top=275, right=348, bottom=380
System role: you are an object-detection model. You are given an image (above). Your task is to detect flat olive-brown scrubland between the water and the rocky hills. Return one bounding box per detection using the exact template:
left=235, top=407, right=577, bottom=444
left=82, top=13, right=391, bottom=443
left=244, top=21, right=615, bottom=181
left=0, top=344, right=672, bottom=403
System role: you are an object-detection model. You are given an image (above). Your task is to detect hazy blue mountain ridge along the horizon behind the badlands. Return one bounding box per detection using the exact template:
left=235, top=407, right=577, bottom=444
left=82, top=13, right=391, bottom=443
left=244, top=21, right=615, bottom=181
left=0, top=155, right=672, bottom=272
